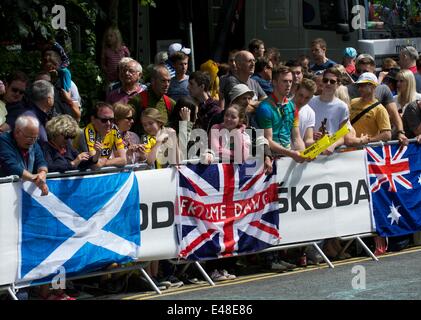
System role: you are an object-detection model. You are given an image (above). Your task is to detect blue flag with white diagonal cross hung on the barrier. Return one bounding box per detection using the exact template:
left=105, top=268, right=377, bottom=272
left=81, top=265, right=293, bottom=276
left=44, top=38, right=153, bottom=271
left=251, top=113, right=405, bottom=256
left=19, top=172, right=140, bottom=281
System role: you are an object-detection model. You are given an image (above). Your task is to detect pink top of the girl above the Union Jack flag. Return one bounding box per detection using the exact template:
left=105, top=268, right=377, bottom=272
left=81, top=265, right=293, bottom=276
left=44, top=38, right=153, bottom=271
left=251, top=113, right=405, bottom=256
left=211, top=123, right=251, bottom=163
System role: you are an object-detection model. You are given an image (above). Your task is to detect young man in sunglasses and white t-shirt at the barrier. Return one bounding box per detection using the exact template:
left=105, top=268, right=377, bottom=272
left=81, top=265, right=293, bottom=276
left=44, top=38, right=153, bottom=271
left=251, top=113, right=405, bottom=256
left=308, top=67, right=349, bottom=155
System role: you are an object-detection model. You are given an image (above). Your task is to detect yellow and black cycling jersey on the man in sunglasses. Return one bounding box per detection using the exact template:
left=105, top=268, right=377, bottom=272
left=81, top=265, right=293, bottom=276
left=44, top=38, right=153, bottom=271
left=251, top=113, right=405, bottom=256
left=83, top=123, right=124, bottom=159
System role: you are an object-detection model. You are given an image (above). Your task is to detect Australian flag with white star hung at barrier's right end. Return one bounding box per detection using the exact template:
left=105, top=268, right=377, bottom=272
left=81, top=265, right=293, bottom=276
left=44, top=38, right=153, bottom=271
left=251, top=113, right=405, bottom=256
left=366, top=144, right=421, bottom=237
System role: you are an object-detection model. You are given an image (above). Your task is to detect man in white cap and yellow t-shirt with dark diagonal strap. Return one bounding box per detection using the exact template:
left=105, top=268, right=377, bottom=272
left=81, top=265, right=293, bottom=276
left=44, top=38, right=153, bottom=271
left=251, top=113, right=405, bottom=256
left=350, top=72, right=392, bottom=144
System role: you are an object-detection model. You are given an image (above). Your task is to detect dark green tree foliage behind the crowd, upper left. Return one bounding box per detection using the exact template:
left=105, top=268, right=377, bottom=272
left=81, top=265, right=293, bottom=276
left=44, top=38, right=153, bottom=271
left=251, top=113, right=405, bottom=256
left=0, top=0, right=155, bottom=118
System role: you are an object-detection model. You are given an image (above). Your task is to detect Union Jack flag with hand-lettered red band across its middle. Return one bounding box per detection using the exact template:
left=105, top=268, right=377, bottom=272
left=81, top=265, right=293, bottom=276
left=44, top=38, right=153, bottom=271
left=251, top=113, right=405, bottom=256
left=177, top=163, right=280, bottom=260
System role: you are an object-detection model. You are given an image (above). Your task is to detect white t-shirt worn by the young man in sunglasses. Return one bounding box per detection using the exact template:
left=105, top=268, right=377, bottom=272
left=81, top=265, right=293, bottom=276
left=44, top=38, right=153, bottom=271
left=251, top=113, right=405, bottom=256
left=308, top=96, right=349, bottom=134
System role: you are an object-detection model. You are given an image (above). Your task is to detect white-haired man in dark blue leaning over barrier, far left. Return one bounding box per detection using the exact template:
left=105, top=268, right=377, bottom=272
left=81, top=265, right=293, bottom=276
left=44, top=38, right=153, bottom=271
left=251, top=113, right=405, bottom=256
left=0, top=115, right=48, bottom=195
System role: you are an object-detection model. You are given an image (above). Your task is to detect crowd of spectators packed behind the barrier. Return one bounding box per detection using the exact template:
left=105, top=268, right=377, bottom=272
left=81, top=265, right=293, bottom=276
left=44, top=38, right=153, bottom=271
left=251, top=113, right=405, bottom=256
left=0, top=28, right=421, bottom=298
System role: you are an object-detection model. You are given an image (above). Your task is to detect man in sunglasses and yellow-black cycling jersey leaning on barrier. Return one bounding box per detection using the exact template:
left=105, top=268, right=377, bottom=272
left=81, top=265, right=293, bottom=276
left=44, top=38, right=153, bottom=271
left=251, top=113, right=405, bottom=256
left=74, top=102, right=127, bottom=168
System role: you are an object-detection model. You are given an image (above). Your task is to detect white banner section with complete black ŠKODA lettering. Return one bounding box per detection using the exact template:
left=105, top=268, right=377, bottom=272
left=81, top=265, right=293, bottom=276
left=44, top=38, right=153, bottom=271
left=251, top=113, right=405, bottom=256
left=277, top=150, right=373, bottom=244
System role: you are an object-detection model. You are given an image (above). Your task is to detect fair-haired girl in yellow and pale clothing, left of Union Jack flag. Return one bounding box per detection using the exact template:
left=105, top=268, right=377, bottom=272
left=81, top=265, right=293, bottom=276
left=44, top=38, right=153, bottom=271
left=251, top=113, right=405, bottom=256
left=141, top=108, right=179, bottom=169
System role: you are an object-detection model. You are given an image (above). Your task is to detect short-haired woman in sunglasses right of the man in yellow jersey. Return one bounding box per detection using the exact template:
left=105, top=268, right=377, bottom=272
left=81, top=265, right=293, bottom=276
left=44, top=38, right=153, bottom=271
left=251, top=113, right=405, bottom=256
left=113, top=103, right=146, bottom=164
